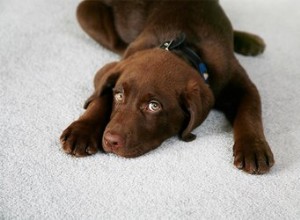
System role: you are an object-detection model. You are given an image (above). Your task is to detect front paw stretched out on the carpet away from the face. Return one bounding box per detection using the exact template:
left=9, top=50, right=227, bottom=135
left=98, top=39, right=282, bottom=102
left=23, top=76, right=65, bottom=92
left=233, top=139, right=274, bottom=174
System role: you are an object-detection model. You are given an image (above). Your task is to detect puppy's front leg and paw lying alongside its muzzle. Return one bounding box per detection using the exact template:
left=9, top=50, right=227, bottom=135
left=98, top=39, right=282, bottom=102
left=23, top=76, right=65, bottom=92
left=60, top=94, right=112, bottom=157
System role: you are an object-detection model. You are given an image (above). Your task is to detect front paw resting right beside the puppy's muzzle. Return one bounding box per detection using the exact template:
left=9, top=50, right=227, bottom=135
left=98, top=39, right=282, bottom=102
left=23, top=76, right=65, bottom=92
left=60, top=120, right=101, bottom=157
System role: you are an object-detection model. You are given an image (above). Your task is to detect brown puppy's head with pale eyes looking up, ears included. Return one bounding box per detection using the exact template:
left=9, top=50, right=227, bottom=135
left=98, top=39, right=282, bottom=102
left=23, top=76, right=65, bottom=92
left=89, top=48, right=214, bottom=157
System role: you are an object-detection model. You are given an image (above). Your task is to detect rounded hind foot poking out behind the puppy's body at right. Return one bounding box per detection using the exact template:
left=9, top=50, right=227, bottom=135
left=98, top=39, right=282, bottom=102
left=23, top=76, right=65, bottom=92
left=234, top=31, right=266, bottom=56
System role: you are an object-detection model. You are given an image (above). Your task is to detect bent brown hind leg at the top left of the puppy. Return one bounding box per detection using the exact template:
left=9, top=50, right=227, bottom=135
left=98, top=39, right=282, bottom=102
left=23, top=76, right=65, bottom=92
left=77, top=0, right=127, bottom=54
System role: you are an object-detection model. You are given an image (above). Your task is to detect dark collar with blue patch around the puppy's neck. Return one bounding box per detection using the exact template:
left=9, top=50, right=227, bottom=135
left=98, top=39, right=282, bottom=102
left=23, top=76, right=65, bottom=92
left=160, top=33, right=209, bottom=83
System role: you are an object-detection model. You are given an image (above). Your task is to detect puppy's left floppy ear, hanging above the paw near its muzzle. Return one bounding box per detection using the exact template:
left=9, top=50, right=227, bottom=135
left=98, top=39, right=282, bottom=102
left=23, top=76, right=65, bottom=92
left=84, top=62, right=121, bottom=109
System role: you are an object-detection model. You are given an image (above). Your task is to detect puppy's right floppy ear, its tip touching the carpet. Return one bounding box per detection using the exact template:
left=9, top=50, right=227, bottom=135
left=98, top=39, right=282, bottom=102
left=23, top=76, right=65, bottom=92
left=180, top=79, right=214, bottom=141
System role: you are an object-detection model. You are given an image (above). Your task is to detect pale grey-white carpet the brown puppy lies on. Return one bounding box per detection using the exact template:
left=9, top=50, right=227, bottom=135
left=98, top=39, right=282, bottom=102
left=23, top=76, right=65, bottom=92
left=0, top=0, right=300, bottom=220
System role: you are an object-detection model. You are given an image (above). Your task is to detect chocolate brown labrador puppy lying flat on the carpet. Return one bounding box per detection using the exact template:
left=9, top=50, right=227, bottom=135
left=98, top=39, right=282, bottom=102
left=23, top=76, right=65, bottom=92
left=61, top=0, right=274, bottom=174
